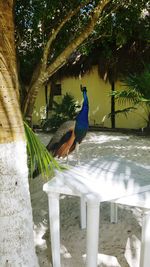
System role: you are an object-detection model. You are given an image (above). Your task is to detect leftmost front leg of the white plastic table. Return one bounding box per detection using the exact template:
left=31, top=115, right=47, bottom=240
left=48, top=193, right=61, bottom=267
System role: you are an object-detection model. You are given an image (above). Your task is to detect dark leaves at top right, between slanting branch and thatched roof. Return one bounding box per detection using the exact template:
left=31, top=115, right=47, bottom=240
left=78, top=0, right=150, bottom=53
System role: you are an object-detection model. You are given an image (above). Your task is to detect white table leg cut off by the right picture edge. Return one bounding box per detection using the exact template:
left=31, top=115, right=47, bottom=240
left=140, top=211, right=150, bottom=267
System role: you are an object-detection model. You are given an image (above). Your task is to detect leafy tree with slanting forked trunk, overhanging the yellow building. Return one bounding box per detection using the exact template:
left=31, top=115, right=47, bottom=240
left=15, top=0, right=150, bottom=120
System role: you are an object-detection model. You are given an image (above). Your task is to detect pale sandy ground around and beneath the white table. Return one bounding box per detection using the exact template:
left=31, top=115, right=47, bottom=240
left=30, top=132, right=150, bottom=267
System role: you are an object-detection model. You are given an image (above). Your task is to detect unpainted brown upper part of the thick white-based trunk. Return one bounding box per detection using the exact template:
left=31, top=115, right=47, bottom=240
left=0, top=0, right=24, bottom=143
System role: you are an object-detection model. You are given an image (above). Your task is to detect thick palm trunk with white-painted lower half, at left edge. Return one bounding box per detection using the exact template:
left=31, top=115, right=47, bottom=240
left=0, top=0, right=39, bottom=267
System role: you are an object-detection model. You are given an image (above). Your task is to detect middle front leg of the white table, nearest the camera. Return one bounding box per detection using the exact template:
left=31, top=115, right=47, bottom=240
left=86, top=201, right=100, bottom=267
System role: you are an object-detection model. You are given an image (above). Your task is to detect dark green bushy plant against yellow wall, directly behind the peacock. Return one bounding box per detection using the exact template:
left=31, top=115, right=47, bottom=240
left=42, top=93, right=80, bottom=131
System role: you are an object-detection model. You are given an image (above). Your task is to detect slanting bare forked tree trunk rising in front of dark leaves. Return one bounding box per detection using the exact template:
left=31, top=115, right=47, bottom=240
left=23, top=0, right=110, bottom=117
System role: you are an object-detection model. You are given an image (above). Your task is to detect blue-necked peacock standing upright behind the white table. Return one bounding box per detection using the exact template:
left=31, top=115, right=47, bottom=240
left=33, top=86, right=89, bottom=178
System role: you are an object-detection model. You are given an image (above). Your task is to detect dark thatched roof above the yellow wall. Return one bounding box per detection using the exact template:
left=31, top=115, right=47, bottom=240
left=53, top=40, right=150, bottom=83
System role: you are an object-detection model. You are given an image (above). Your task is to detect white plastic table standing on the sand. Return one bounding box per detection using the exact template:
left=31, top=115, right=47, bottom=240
left=43, top=157, right=150, bottom=267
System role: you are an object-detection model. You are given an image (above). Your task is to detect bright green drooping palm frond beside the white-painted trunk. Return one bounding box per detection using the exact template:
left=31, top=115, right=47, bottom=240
left=24, top=122, right=62, bottom=177
